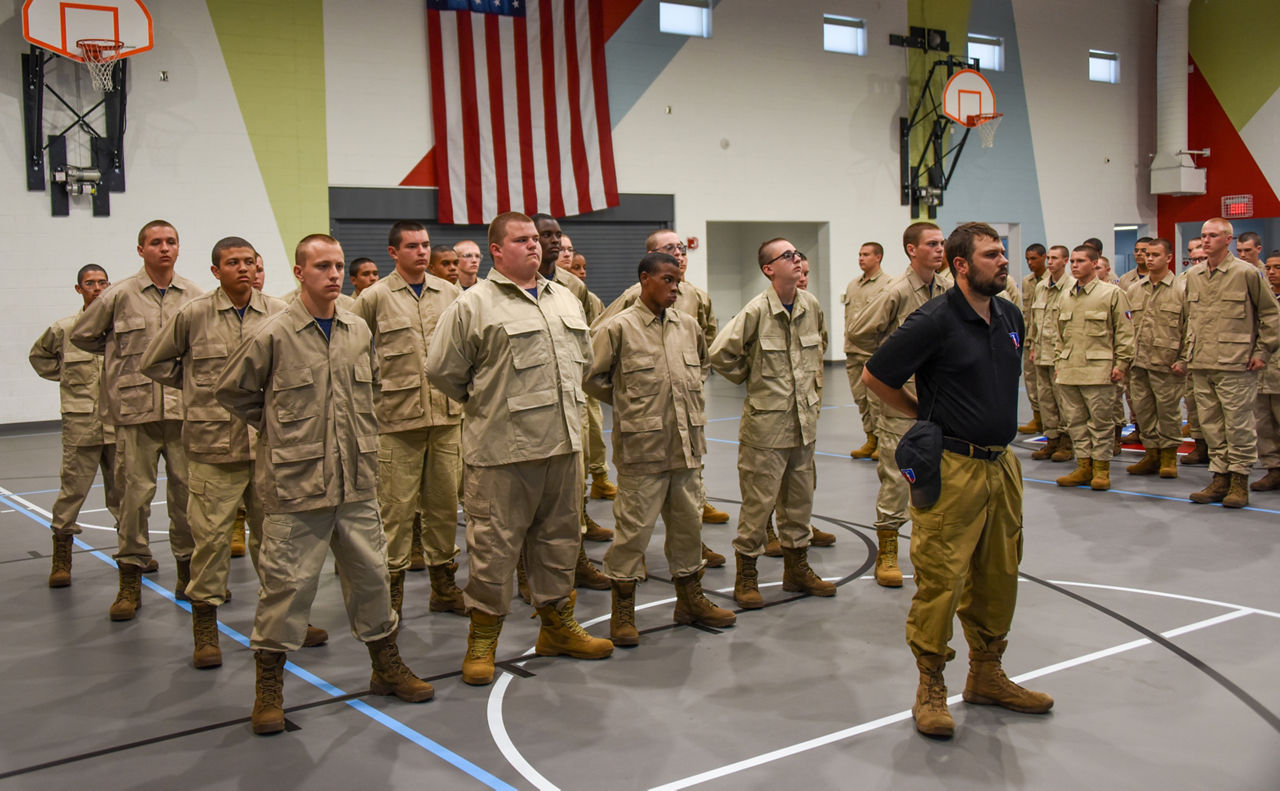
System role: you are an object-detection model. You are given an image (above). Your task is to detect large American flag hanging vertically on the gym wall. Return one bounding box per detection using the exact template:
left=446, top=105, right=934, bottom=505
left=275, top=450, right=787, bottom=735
left=426, top=0, right=618, bottom=224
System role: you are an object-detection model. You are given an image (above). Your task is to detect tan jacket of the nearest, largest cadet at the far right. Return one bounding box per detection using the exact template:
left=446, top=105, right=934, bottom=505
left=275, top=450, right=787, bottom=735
left=1181, top=253, right=1280, bottom=371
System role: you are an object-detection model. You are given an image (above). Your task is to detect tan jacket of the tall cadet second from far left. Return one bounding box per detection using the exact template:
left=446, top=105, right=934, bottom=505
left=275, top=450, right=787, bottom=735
left=72, top=268, right=205, bottom=426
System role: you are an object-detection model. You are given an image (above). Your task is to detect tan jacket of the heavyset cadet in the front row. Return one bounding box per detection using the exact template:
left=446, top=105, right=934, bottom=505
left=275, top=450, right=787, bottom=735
left=426, top=269, right=591, bottom=467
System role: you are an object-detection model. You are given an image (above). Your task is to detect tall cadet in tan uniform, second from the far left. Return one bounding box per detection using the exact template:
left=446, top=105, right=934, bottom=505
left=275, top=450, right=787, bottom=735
left=72, top=220, right=204, bottom=621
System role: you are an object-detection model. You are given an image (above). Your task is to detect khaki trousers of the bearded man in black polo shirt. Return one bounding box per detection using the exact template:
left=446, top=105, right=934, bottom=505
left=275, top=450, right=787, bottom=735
left=906, top=449, right=1023, bottom=660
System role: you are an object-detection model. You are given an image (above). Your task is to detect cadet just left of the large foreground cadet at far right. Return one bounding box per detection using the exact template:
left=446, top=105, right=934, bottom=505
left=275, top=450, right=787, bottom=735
left=1126, top=239, right=1187, bottom=477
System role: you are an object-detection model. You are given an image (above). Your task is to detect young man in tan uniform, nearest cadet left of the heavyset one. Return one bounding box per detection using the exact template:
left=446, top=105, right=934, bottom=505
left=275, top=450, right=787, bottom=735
left=214, top=234, right=434, bottom=733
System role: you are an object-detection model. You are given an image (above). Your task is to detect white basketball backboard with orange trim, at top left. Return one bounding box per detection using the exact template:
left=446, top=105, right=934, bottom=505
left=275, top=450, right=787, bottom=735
left=22, top=0, right=155, bottom=63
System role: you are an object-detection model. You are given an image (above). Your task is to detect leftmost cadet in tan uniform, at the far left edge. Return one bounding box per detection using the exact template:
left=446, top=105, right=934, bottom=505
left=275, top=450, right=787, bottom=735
left=27, top=264, right=120, bottom=587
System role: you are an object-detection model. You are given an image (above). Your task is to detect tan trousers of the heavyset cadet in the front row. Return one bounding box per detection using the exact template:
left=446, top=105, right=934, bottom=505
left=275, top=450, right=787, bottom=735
left=462, top=453, right=582, bottom=616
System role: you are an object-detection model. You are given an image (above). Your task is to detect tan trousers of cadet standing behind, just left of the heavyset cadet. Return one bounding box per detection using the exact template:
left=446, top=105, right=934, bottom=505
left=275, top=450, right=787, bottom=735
left=378, top=424, right=462, bottom=571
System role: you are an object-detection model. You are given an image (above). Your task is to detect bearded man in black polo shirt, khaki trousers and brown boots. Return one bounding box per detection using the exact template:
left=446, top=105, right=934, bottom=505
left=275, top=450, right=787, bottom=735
left=863, top=223, right=1053, bottom=737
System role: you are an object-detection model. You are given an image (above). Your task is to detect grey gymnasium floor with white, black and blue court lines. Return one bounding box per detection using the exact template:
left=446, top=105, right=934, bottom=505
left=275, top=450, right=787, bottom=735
left=0, top=366, right=1280, bottom=791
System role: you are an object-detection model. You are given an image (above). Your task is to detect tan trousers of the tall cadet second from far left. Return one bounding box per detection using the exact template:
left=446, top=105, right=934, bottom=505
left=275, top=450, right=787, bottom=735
left=115, top=420, right=196, bottom=566
